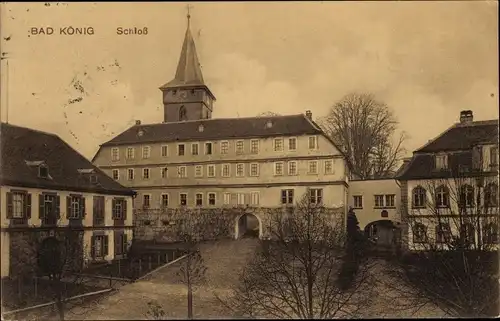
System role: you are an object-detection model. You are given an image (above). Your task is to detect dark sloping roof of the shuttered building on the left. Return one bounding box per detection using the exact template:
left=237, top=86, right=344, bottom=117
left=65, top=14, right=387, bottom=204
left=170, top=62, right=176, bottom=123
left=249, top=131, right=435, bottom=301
left=0, top=123, right=135, bottom=195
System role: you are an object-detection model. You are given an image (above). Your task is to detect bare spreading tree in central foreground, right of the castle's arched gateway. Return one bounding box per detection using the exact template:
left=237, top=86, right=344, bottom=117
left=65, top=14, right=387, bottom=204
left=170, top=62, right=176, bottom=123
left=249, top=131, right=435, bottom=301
left=218, top=191, right=373, bottom=319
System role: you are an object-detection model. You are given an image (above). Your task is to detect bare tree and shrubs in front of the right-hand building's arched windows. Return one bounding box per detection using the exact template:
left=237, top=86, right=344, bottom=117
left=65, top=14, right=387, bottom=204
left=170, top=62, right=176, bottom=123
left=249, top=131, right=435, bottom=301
left=388, top=168, right=499, bottom=317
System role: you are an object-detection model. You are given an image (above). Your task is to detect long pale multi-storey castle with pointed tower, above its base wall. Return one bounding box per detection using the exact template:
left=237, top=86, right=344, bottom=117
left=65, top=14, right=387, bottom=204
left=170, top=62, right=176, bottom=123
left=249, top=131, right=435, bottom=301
left=93, top=14, right=348, bottom=235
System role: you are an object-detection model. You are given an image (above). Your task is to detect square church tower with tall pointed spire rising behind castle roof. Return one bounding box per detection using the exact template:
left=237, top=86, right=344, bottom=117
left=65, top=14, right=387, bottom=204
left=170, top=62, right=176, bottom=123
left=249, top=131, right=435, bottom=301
left=160, top=12, right=215, bottom=123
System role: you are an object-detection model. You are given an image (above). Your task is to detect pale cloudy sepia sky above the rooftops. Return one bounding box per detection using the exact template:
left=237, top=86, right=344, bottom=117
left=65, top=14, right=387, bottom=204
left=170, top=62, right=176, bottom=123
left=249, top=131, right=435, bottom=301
left=0, top=1, right=499, bottom=159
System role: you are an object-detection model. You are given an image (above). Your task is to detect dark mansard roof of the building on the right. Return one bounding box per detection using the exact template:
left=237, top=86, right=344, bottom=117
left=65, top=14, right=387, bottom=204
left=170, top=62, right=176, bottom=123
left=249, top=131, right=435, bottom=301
left=396, top=120, right=498, bottom=180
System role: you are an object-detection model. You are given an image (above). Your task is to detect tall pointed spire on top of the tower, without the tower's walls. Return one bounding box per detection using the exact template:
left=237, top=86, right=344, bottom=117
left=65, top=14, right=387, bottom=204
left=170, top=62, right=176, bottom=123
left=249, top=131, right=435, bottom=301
left=163, top=6, right=205, bottom=87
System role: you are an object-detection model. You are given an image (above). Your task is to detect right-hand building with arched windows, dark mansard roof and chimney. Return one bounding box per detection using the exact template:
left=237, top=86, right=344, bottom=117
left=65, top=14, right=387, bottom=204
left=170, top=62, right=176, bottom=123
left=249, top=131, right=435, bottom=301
left=397, top=111, right=499, bottom=250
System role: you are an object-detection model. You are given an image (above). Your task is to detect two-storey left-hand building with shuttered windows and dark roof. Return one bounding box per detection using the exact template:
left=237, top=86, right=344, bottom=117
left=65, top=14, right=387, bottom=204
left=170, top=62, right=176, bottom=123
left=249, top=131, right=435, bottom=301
left=0, top=123, right=134, bottom=277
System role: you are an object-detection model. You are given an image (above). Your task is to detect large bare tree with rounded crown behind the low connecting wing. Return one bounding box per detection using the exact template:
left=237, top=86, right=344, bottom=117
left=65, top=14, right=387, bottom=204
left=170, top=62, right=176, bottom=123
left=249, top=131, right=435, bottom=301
left=319, top=93, right=405, bottom=179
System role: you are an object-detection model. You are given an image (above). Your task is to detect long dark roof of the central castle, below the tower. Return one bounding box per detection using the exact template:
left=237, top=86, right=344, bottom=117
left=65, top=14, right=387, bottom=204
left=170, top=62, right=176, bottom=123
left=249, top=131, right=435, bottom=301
left=101, top=114, right=322, bottom=146
